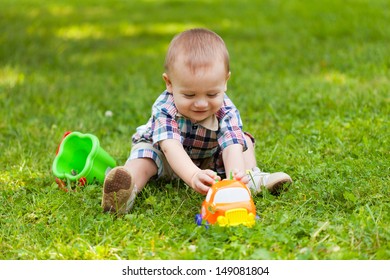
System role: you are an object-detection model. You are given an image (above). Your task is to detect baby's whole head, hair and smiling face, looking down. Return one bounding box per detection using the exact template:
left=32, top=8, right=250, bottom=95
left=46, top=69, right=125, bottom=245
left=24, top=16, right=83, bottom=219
left=163, top=28, right=230, bottom=122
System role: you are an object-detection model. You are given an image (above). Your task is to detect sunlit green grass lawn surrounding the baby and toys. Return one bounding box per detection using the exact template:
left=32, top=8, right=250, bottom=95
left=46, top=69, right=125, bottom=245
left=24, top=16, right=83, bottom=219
left=0, top=0, right=390, bottom=259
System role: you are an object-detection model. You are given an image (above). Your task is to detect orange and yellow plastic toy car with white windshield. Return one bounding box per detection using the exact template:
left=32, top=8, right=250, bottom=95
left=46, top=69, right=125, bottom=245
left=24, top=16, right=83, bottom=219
left=195, top=180, right=256, bottom=227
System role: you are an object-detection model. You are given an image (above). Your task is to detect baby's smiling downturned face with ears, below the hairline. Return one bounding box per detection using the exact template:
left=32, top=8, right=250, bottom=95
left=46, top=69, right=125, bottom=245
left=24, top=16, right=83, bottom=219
left=163, top=59, right=230, bottom=122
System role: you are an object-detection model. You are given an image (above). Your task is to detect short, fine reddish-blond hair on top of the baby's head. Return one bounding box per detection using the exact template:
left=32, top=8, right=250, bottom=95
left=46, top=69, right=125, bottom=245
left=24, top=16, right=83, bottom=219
left=164, top=28, right=230, bottom=73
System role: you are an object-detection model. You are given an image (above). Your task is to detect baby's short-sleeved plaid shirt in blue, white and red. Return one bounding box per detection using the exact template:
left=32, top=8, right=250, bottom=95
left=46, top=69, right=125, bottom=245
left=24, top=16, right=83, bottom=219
left=132, top=91, right=247, bottom=175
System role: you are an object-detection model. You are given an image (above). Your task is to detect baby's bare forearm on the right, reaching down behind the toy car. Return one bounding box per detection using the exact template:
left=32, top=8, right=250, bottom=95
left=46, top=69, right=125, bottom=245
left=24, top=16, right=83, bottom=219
left=222, top=144, right=249, bottom=184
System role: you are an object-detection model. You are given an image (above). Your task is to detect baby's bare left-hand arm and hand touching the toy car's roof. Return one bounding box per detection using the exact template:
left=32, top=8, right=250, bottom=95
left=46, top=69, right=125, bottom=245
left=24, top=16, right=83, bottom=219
left=159, top=139, right=218, bottom=194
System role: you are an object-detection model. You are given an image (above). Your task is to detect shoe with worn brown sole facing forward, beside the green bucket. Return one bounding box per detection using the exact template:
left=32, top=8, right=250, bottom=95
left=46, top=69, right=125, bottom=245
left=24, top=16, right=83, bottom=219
left=102, top=166, right=134, bottom=214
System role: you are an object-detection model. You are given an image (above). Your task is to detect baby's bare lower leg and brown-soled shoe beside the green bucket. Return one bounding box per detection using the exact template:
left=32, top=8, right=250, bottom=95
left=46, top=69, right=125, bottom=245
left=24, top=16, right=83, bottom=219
left=102, top=158, right=157, bottom=214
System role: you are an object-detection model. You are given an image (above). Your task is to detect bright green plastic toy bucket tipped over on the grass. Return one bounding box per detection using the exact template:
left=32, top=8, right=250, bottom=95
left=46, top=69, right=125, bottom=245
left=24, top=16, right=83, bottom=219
left=52, top=132, right=116, bottom=183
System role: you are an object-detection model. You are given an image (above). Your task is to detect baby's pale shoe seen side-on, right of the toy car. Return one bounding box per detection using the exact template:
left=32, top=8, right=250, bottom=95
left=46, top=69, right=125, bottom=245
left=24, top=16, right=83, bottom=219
left=248, top=167, right=292, bottom=194
